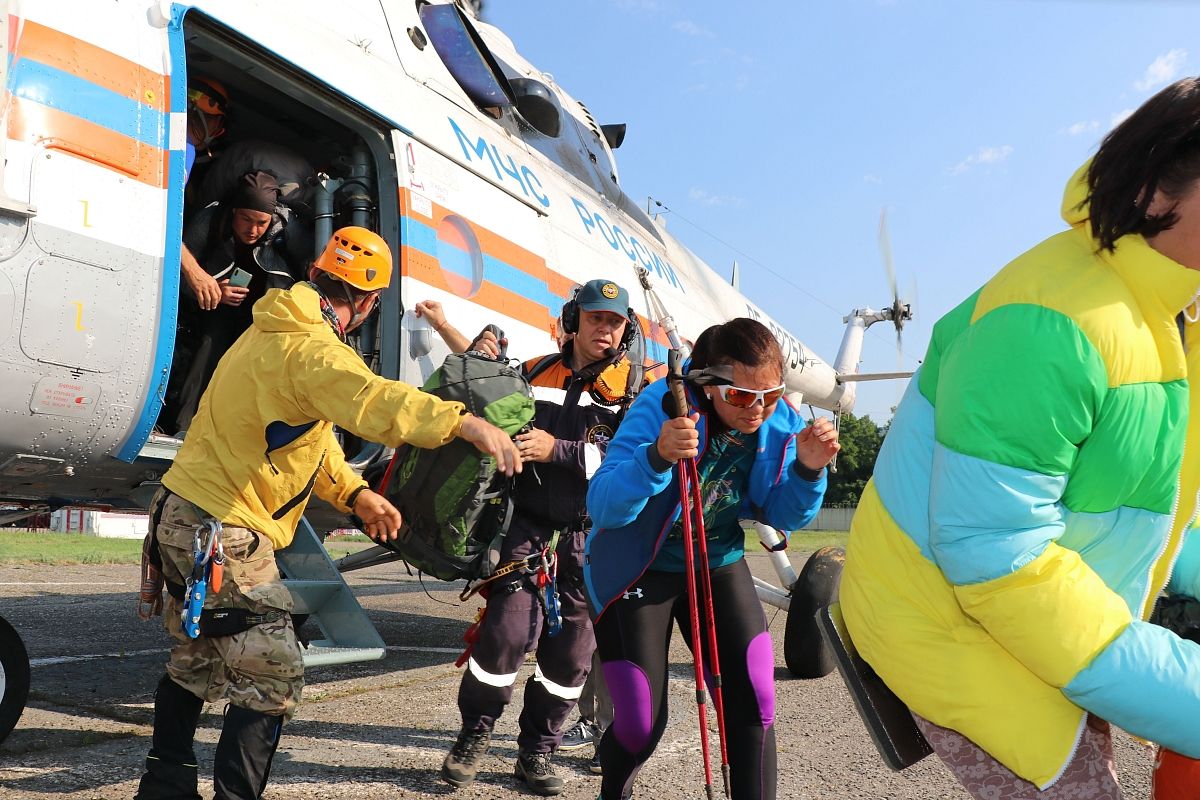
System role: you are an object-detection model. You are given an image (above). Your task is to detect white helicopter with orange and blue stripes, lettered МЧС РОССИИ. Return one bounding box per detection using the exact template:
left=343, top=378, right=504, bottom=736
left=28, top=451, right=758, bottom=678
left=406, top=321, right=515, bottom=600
left=0, top=0, right=912, bottom=724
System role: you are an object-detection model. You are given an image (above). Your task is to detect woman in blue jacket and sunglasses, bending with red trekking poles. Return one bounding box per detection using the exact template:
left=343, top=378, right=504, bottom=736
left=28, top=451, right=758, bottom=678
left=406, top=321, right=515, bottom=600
left=584, top=318, right=839, bottom=800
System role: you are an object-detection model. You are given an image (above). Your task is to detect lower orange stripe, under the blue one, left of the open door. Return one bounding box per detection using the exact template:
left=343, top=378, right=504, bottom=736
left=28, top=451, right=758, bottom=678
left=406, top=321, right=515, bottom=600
left=8, top=97, right=170, bottom=188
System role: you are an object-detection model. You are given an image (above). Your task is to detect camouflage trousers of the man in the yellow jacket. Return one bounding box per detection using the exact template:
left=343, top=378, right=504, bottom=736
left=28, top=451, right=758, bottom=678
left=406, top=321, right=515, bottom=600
left=150, top=491, right=304, bottom=720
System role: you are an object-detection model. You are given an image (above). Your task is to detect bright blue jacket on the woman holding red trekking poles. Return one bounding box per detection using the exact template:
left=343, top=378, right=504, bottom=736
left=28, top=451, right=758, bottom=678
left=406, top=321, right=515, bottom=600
left=583, top=380, right=826, bottom=619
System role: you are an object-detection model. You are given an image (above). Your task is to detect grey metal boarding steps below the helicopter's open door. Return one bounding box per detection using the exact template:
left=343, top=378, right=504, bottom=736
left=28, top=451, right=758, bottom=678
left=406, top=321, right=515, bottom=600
left=134, top=433, right=386, bottom=667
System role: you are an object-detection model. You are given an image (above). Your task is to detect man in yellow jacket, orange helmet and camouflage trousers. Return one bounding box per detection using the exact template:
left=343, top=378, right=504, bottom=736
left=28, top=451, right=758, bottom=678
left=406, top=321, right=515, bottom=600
left=137, top=228, right=521, bottom=800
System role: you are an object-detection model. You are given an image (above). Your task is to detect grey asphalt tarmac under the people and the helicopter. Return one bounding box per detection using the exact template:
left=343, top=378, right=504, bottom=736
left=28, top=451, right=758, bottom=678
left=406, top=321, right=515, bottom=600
left=0, top=555, right=1151, bottom=800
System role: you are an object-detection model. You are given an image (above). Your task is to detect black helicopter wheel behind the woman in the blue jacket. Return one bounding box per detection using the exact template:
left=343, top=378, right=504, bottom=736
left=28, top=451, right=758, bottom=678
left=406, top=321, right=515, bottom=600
left=784, top=547, right=846, bottom=679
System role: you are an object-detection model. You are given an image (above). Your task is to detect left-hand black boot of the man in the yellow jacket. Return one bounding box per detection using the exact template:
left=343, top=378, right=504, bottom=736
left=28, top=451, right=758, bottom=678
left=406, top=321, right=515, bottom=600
left=134, top=675, right=204, bottom=800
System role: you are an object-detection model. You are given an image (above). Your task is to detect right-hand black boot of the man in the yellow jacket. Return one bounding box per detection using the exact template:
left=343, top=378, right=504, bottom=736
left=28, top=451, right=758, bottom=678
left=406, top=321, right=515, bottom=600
left=212, top=704, right=283, bottom=800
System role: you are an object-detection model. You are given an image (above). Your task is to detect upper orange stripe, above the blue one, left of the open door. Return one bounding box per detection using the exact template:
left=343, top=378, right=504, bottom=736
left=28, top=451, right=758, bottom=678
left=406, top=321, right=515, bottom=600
left=8, top=17, right=170, bottom=112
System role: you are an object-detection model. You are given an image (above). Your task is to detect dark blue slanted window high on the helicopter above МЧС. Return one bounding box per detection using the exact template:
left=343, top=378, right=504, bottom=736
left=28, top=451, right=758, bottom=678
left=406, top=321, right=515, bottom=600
left=418, top=4, right=515, bottom=110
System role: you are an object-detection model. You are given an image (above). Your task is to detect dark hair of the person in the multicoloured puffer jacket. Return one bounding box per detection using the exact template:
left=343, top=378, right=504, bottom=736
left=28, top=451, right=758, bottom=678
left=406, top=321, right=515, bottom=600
left=1085, top=78, right=1200, bottom=251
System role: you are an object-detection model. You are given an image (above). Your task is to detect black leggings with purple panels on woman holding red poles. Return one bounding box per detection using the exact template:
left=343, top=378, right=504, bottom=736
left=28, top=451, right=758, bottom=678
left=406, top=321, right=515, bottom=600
left=595, top=560, right=775, bottom=800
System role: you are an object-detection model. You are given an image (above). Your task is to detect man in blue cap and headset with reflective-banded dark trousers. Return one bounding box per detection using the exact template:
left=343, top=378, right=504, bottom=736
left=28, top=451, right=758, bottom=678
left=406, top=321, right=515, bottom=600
left=442, top=278, right=641, bottom=795
